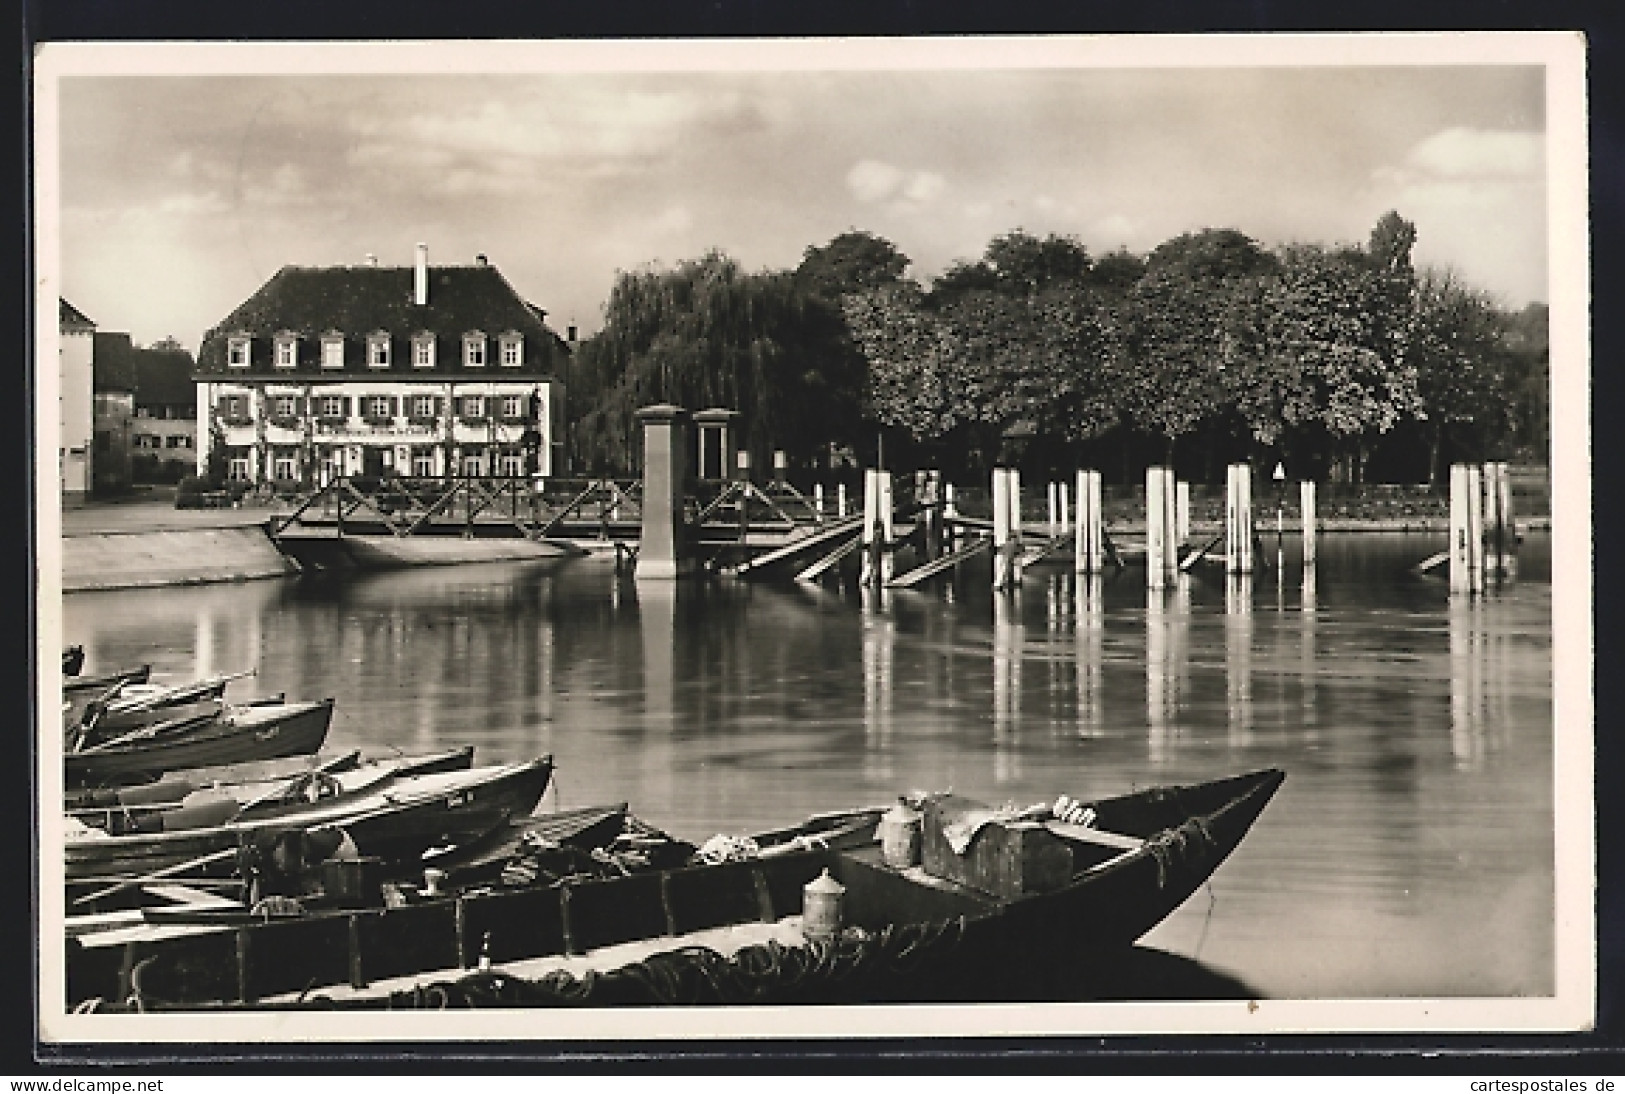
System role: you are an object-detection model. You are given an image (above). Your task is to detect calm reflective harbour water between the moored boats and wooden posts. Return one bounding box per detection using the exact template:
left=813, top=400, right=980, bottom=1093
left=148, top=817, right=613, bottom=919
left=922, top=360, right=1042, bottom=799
left=65, top=535, right=1554, bottom=998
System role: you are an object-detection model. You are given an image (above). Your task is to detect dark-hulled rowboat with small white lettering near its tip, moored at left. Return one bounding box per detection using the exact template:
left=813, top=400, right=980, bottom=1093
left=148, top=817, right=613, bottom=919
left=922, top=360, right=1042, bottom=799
left=62, top=699, right=333, bottom=787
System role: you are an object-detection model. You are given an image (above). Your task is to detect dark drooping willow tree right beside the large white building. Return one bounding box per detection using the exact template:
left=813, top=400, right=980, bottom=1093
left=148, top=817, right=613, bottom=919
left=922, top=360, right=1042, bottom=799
left=577, top=252, right=861, bottom=470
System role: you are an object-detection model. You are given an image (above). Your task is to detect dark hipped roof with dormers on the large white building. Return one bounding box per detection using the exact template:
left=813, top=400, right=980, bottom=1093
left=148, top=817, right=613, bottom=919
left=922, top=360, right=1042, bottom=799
left=197, top=265, right=567, bottom=374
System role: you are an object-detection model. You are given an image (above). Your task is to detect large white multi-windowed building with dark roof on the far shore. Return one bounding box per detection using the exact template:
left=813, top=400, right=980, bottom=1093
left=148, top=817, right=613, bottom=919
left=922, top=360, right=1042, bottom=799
left=193, top=244, right=569, bottom=486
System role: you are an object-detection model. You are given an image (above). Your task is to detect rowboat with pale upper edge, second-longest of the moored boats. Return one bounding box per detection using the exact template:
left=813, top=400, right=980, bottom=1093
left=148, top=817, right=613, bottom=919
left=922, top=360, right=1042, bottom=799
left=63, top=756, right=553, bottom=884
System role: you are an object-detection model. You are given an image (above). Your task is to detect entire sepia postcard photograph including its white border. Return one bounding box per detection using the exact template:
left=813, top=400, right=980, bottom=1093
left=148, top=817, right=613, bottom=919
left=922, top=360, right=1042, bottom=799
left=33, top=33, right=1596, bottom=1045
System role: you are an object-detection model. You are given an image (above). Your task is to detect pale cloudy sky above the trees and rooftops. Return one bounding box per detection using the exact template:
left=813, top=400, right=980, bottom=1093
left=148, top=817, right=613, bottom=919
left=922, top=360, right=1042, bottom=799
left=50, top=55, right=1549, bottom=349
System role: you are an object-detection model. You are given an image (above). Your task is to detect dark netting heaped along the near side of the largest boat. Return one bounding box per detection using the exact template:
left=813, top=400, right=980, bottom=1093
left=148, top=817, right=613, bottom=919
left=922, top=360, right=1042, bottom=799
left=323, top=918, right=965, bottom=1009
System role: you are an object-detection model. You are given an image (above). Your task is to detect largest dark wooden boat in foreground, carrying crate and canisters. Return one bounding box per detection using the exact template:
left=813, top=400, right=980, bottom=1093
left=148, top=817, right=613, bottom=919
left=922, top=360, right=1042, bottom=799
left=82, top=771, right=1284, bottom=1011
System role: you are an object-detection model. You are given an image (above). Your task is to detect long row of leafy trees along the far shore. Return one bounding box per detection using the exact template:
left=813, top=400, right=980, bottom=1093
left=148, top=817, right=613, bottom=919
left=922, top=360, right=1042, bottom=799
left=566, top=213, right=1549, bottom=481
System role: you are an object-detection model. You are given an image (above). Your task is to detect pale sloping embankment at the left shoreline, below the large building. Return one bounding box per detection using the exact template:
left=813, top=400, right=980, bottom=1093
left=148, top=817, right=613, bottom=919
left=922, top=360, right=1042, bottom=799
left=62, top=523, right=299, bottom=593
